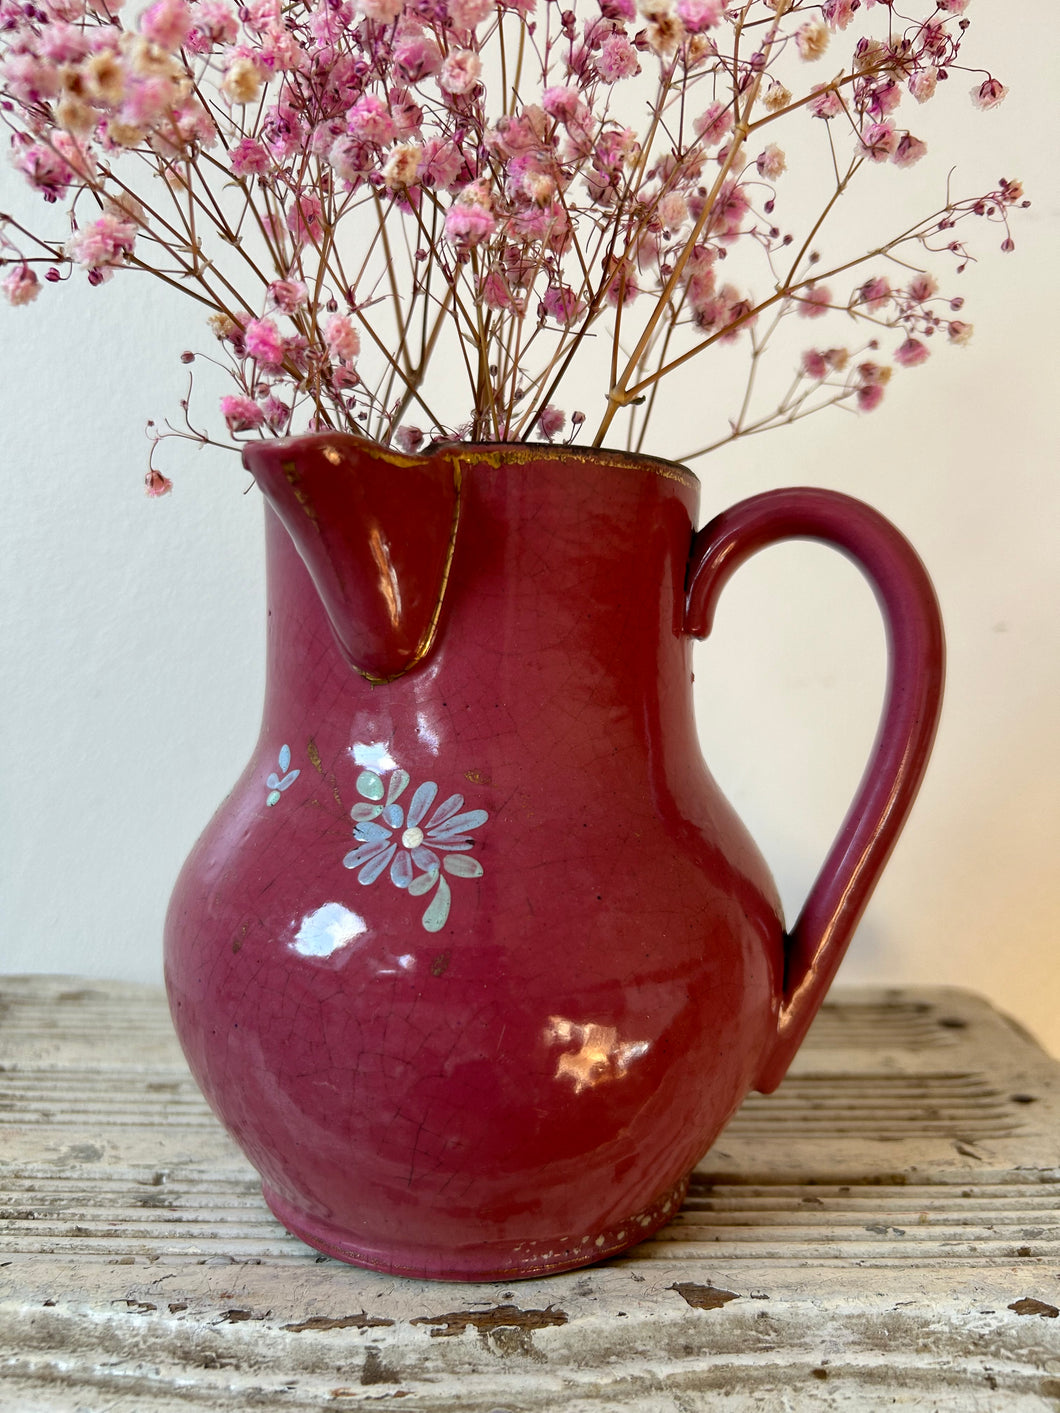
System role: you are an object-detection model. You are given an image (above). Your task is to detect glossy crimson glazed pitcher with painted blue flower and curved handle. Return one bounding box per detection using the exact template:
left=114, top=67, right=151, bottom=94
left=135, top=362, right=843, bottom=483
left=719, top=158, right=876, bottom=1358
left=165, top=434, right=943, bottom=1280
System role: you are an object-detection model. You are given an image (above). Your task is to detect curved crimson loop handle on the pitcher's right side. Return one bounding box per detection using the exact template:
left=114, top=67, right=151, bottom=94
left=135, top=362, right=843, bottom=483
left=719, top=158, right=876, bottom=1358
left=684, top=487, right=946, bottom=1094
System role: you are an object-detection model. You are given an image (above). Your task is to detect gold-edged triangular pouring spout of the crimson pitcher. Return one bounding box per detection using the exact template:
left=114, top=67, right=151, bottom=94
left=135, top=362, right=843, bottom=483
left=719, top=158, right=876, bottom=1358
left=243, top=432, right=461, bottom=682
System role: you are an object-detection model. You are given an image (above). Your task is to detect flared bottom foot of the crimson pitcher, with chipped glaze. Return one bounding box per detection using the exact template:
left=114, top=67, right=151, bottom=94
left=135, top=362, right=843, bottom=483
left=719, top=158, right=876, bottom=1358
left=261, top=1174, right=691, bottom=1280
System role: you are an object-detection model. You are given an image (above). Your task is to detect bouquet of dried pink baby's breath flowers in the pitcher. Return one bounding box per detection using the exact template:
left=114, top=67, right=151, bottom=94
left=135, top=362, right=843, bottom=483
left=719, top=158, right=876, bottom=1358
left=0, top=0, right=1026, bottom=495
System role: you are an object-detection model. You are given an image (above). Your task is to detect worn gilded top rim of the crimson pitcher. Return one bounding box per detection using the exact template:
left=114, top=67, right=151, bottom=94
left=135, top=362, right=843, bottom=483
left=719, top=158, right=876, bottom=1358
left=243, top=430, right=701, bottom=490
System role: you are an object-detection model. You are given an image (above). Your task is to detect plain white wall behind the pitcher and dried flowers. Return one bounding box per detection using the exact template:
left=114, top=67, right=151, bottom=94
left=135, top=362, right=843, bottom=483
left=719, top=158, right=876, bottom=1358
left=0, top=8, right=1060, bottom=1054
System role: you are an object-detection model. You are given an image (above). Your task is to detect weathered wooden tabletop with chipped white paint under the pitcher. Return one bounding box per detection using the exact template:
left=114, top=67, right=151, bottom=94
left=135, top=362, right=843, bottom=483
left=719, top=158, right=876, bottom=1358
left=0, top=976, right=1060, bottom=1413
